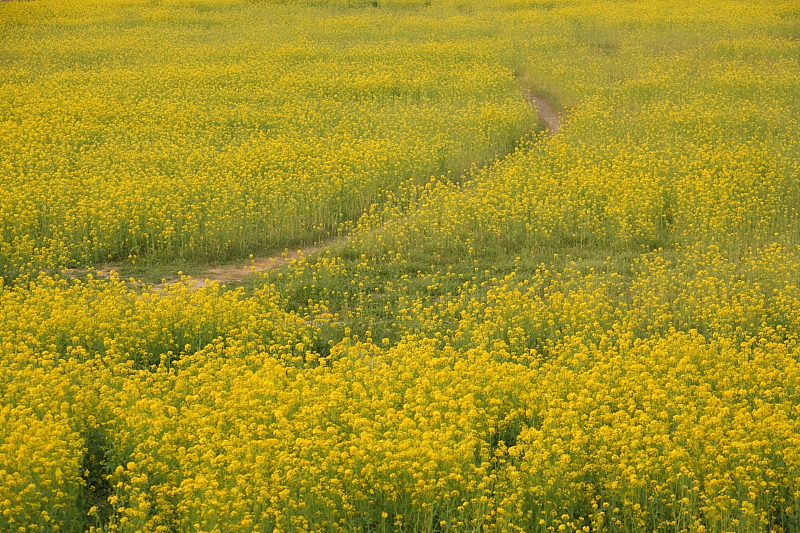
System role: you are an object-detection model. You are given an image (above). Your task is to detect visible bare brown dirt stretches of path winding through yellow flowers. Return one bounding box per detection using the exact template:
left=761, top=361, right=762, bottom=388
left=84, top=89, right=561, bottom=290
